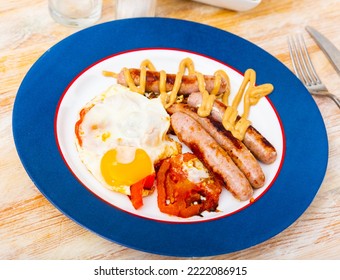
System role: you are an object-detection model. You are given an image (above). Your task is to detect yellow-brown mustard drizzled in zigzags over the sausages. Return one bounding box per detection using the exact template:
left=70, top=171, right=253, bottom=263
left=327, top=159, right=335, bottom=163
left=103, top=58, right=274, bottom=140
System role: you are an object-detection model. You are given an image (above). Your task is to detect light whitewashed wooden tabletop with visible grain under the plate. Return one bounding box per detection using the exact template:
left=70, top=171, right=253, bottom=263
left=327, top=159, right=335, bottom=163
left=0, top=0, right=340, bottom=259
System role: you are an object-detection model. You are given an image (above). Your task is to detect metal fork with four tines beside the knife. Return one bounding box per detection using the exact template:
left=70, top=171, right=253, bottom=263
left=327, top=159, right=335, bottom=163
left=288, top=34, right=340, bottom=109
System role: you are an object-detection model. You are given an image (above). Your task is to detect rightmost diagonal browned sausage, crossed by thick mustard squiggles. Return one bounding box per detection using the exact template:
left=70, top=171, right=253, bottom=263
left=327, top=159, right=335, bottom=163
left=187, top=92, right=277, bottom=164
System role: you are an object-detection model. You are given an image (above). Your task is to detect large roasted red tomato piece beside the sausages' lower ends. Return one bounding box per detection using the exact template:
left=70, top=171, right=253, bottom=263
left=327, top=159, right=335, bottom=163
left=157, top=153, right=222, bottom=218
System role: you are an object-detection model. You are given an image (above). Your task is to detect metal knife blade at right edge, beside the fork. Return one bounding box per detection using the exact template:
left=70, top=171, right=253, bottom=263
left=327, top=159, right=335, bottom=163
left=306, top=26, right=340, bottom=75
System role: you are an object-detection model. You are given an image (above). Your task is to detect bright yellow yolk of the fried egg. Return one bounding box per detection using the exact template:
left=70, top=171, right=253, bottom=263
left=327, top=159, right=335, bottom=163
left=100, top=149, right=153, bottom=186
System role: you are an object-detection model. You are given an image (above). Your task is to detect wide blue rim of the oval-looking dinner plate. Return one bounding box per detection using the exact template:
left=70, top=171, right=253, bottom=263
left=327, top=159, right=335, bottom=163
left=13, top=18, right=328, bottom=257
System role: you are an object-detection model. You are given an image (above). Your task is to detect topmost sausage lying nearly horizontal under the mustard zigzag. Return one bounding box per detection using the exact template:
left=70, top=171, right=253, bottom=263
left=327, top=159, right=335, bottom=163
left=117, top=68, right=229, bottom=95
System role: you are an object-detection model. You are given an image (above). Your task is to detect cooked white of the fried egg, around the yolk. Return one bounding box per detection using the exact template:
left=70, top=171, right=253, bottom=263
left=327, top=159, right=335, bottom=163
left=76, top=85, right=180, bottom=195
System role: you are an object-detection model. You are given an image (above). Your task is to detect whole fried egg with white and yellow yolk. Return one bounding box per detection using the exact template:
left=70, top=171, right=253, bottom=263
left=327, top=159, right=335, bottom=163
left=75, top=85, right=180, bottom=195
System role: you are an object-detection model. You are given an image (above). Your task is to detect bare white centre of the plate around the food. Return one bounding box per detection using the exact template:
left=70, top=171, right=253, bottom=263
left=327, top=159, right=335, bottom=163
left=56, top=49, right=283, bottom=223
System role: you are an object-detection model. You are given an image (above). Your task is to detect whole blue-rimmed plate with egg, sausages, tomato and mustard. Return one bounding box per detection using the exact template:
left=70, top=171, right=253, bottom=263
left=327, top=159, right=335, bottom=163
left=13, top=18, right=328, bottom=256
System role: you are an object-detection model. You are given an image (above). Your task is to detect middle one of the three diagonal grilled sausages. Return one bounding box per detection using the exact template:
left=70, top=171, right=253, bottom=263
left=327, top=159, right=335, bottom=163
left=167, top=104, right=265, bottom=188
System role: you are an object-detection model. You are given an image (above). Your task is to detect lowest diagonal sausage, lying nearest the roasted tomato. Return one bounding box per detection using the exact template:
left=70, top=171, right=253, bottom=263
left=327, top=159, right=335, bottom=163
left=170, top=112, right=253, bottom=201
